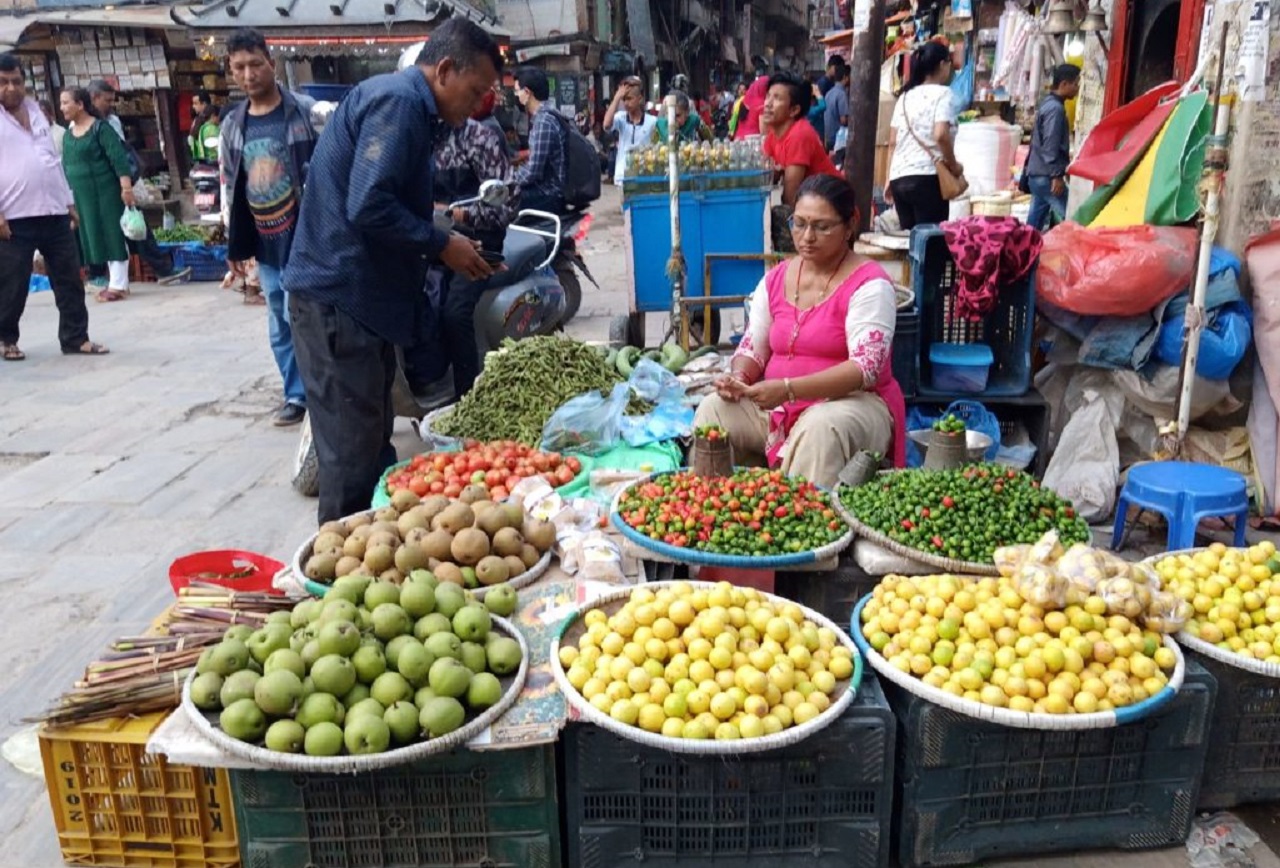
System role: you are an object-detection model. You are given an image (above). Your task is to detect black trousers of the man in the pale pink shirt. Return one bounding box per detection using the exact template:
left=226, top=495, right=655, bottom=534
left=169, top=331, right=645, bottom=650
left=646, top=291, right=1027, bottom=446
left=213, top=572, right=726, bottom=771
left=0, top=214, right=88, bottom=350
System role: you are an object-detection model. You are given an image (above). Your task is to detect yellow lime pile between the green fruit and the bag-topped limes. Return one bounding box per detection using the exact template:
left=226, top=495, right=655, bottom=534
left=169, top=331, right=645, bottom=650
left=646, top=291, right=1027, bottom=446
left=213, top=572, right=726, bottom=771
left=559, top=581, right=854, bottom=740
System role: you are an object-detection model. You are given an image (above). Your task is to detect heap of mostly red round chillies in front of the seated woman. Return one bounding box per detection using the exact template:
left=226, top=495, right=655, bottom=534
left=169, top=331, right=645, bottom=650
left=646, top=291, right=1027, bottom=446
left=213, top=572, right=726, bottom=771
left=618, top=470, right=847, bottom=557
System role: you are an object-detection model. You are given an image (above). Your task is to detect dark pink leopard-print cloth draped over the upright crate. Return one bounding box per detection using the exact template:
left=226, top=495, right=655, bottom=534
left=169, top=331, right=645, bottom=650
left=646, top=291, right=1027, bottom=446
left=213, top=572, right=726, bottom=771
left=942, top=216, right=1043, bottom=320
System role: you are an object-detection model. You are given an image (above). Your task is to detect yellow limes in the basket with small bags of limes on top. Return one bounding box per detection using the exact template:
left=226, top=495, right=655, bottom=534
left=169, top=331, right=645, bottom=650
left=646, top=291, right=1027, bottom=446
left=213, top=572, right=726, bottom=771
left=861, top=575, right=1178, bottom=714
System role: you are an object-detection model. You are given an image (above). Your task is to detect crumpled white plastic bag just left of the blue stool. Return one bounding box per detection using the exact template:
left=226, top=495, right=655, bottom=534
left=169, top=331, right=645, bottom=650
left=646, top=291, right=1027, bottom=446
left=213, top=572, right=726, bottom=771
left=1044, top=392, right=1120, bottom=521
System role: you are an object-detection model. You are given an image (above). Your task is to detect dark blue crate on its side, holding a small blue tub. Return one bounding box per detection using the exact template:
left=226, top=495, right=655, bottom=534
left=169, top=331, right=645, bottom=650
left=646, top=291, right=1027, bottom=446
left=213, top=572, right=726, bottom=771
left=911, top=225, right=1036, bottom=398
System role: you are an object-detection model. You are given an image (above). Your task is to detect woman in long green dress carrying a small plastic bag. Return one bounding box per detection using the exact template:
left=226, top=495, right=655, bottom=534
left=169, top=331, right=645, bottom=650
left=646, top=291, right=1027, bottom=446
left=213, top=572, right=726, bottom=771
left=60, top=88, right=134, bottom=301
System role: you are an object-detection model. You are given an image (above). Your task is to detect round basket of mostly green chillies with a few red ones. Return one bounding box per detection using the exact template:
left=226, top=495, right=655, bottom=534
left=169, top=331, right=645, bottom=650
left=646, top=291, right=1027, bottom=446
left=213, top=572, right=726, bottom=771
left=837, top=463, right=1089, bottom=567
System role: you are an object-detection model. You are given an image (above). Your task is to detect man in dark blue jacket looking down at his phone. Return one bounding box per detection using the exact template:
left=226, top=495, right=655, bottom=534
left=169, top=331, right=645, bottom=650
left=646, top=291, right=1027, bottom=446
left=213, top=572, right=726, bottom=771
left=284, top=18, right=502, bottom=522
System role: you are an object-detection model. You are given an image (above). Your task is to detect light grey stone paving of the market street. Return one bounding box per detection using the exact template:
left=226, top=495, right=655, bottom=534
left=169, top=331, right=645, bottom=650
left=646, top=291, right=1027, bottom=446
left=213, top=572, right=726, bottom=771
left=0, top=188, right=1280, bottom=868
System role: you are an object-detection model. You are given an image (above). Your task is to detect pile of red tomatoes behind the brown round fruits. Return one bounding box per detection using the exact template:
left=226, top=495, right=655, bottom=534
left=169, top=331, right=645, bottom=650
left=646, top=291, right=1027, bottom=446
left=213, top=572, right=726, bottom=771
left=387, top=440, right=582, bottom=501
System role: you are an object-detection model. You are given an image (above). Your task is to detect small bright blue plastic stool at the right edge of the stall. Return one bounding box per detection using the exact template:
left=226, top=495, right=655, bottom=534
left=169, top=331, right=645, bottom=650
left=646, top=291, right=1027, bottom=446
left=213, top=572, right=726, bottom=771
left=1111, top=461, right=1249, bottom=551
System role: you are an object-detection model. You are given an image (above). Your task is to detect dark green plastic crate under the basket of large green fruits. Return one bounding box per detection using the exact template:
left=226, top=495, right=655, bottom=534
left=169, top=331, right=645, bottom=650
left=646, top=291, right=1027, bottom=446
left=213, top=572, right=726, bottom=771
left=232, top=745, right=561, bottom=868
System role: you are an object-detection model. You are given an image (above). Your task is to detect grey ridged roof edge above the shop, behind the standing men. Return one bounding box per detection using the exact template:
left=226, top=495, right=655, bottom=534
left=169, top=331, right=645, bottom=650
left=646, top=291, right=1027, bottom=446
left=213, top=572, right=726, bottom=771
left=173, top=0, right=502, bottom=36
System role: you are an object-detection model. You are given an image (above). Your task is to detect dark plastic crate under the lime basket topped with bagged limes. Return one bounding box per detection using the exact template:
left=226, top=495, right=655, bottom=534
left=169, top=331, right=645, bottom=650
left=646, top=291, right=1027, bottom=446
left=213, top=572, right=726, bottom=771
left=888, top=661, right=1217, bottom=868
